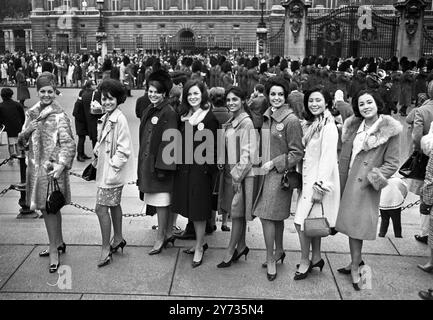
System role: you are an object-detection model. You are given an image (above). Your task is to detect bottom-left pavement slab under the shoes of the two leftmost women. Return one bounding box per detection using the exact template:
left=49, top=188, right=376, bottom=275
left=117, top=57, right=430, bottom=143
left=2, top=246, right=177, bottom=295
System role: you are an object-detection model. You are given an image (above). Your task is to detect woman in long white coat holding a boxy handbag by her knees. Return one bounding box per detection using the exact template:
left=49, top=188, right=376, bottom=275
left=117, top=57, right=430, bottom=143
left=294, top=87, right=340, bottom=280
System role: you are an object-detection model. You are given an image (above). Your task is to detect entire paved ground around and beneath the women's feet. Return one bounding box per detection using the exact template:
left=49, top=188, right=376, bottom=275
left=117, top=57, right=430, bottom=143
left=0, top=89, right=433, bottom=300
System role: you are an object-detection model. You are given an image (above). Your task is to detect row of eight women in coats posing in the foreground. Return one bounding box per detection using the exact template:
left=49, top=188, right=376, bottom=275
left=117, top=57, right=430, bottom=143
left=21, top=70, right=402, bottom=290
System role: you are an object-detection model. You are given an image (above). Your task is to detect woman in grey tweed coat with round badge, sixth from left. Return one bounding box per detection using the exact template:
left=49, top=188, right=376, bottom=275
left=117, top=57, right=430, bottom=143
left=253, top=78, right=304, bottom=281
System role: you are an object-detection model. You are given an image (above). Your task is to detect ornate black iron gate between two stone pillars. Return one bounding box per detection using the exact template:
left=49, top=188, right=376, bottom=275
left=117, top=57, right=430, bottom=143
left=306, top=6, right=399, bottom=58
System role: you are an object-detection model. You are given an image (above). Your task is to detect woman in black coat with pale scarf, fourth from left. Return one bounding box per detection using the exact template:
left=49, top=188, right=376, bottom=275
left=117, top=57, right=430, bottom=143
left=172, top=80, right=219, bottom=268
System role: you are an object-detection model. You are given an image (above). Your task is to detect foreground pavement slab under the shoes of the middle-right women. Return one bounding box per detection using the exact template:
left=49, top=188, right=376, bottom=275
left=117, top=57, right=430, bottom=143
left=170, top=249, right=340, bottom=300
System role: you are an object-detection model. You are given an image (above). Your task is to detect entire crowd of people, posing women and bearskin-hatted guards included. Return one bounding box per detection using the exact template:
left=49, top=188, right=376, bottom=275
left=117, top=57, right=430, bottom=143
left=0, top=48, right=433, bottom=299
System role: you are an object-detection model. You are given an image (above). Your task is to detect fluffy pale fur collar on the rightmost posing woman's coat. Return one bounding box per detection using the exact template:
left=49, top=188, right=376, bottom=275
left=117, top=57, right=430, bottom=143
left=341, top=115, right=403, bottom=151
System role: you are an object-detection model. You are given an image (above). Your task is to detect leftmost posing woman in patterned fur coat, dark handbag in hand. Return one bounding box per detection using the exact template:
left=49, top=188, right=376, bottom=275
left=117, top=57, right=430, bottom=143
left=18, top=72, right=75, bottom=273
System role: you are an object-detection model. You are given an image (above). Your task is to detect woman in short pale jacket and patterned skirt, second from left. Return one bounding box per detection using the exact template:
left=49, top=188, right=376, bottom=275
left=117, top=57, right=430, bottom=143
left=94, top=79, right=134, bottom=267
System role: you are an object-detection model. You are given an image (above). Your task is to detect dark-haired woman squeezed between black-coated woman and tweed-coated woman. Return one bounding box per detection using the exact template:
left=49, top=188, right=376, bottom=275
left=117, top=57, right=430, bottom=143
left=217, top=87, right=258, bottom=268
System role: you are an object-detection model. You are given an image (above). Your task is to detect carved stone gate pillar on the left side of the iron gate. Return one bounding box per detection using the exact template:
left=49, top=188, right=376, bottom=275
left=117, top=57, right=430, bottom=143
left=281, top=0, right=311, bottom=59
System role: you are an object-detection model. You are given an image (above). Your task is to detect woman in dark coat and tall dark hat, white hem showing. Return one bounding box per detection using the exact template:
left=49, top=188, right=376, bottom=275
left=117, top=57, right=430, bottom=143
left=137, top=70, right=178, bottom=255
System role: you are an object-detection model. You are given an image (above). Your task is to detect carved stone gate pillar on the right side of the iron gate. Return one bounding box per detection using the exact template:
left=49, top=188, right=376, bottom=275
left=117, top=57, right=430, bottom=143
left=394, top=0, right=427, bottom=61
